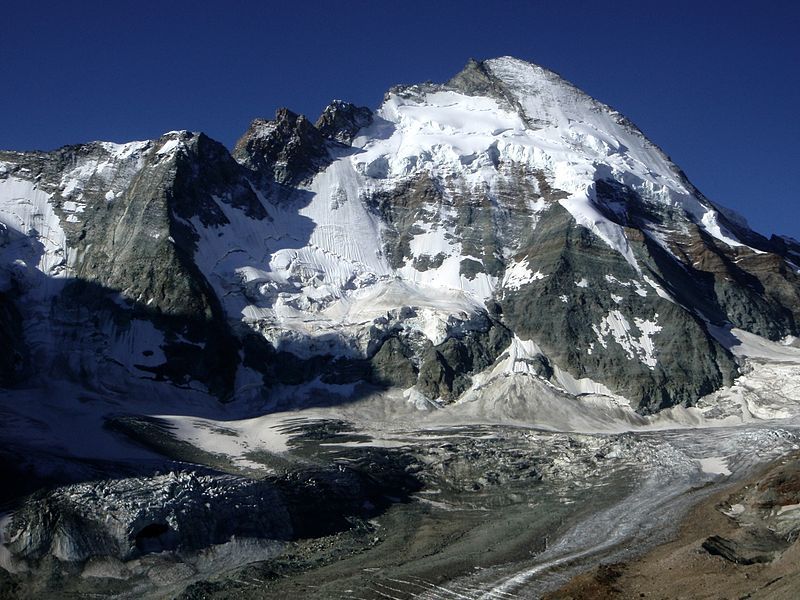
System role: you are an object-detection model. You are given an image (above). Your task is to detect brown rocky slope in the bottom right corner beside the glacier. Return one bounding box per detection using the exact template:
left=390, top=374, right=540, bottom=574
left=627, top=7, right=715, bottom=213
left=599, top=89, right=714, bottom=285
left=546, top=454, right=800, bottom=600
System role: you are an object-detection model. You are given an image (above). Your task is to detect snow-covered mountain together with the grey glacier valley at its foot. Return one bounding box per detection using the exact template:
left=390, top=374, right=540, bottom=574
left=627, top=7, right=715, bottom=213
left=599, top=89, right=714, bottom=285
left=0, top=58, right=800, bottom=599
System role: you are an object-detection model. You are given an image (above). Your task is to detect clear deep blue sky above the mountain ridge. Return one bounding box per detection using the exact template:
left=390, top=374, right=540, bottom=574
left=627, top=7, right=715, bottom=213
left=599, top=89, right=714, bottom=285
left=0, top=0, right=800, bottom=239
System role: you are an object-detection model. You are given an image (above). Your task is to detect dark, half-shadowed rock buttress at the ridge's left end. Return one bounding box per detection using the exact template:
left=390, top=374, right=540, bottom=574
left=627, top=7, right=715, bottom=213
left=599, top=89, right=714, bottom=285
left=0, top=133, right=250, bottom=397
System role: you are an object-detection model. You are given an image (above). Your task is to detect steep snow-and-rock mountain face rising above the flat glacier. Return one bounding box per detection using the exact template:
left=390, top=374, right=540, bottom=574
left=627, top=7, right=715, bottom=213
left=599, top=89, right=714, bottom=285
left=0, top=58, right=800, bottom=413
